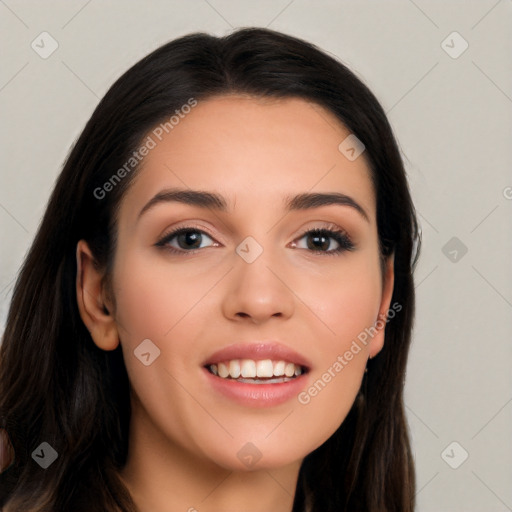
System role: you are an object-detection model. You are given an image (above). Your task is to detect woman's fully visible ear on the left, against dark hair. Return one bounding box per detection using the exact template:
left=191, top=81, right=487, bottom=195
left=76, top=240, right=119, bottom=350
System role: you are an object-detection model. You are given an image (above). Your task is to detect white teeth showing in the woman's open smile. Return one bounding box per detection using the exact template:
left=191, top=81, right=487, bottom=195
left=208, top=359, right=304, bottom=383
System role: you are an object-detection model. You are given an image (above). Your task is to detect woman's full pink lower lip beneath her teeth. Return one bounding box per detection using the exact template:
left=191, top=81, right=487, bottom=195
left=203, top=368, right=307, bottom=407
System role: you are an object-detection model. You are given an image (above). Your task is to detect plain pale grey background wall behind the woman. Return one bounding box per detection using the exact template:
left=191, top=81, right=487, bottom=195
left=0, top=0, right=512, bottom=512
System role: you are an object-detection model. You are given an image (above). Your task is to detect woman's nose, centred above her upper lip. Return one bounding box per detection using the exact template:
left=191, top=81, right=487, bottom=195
left=223, top=244, right=295, bottom=324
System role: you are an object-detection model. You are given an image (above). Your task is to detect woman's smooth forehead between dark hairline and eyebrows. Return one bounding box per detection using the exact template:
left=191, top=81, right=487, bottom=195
left=121, top=95, right=375, bottom=224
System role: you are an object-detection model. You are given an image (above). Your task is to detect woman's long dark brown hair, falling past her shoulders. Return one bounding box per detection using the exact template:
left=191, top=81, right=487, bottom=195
left=0, top=28, right=418, bottom=512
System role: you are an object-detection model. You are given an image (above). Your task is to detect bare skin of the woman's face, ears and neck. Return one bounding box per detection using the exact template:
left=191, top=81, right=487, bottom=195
left=77, top=95, right=393, bottom=512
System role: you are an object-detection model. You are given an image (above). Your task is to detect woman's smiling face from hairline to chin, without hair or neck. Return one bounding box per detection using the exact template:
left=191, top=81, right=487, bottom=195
left=105, top=96, right=392, bottom=470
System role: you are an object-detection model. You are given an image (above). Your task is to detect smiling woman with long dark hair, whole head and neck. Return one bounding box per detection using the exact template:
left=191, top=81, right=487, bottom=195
left=0, top=29, right=419, bottom=512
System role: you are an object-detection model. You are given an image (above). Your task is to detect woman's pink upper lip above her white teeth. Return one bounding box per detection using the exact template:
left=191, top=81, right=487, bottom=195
left=203, top=341, right=311, bottom=369
